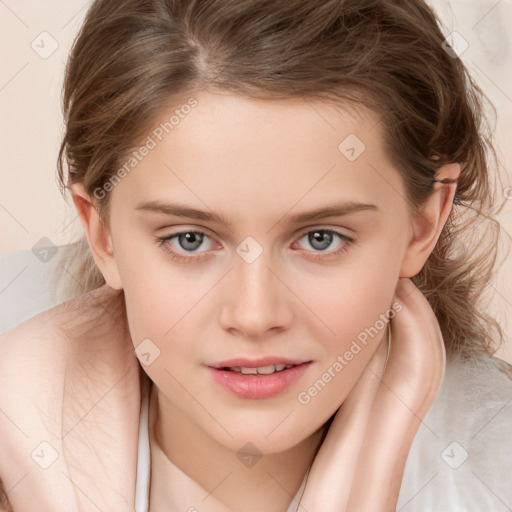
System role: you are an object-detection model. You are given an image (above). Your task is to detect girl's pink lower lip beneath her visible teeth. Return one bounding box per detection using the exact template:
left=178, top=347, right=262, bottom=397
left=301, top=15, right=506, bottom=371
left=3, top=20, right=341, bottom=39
left=208, top=362, right=311, bottom=398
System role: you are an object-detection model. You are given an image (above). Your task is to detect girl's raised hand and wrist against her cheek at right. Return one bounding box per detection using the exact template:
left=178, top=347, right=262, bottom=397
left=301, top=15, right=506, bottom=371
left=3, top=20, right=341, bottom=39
left=299, top=278, right=446, bottom=512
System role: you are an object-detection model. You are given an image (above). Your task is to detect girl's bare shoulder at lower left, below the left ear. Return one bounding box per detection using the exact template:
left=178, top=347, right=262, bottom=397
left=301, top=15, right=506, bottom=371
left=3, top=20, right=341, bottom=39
left=0, top=287, right=140, bottom=511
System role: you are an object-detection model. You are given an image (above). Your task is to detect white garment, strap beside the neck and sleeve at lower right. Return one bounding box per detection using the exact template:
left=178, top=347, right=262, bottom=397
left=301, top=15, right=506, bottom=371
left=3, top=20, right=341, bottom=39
left=135, top=357, right=512, bottom=512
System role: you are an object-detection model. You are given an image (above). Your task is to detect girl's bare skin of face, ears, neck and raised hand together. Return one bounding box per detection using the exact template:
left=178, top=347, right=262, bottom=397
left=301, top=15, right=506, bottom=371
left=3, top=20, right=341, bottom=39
left=0, top=92, right=460, bottom=512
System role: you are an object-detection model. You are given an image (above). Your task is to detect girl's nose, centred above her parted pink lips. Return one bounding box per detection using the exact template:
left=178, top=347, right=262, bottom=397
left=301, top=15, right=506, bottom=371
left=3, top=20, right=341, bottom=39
left=220, top=252, right=293, bottom=341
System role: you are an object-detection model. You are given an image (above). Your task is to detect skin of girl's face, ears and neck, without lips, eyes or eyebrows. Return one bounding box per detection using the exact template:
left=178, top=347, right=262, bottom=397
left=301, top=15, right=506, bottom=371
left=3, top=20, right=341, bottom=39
left=74, top=93, right=456, bottom=511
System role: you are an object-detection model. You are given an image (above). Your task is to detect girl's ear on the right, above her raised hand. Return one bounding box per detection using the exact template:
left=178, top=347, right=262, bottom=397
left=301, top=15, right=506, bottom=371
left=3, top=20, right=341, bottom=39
left=400, top=163, right=460, bottom=277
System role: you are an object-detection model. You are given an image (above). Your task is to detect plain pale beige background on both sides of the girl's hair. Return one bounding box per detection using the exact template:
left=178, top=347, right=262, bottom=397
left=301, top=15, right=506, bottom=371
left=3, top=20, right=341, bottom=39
left=0, top=0, right=512, bottom=363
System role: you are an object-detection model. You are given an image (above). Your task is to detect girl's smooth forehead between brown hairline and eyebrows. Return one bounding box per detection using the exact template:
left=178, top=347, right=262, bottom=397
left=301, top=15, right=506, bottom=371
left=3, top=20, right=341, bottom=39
left=109, top=92, right=401, bottom=220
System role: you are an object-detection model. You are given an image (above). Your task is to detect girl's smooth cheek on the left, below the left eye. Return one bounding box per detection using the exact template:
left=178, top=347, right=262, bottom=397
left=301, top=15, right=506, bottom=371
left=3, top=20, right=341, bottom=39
left=121, top=253, right=214, bottom=391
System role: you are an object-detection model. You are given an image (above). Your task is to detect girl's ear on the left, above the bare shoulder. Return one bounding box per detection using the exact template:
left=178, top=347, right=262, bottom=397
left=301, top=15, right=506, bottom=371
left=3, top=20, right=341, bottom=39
left=70, top=183, right=123, bottom=290
